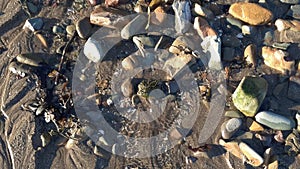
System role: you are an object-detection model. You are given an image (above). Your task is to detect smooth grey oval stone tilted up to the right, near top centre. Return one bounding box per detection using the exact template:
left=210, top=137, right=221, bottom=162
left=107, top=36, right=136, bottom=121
left=121, top=15, right=147, bottom=39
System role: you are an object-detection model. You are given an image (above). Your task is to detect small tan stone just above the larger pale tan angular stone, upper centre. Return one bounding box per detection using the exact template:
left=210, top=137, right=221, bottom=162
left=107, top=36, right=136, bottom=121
left=169, top=36, right=194, bottom=54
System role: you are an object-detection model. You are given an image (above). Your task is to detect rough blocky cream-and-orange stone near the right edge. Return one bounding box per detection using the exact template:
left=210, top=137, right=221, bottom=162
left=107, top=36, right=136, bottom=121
left=262, top=46, right=295, bottom=73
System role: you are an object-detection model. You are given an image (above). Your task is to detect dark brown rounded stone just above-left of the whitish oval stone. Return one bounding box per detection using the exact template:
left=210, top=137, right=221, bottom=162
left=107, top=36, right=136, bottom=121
left=75, top=17, right=92, bottom=39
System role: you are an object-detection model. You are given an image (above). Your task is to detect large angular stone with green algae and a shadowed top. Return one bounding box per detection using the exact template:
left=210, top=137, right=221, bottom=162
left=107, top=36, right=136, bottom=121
left=232, top=76, right=268, bottom=117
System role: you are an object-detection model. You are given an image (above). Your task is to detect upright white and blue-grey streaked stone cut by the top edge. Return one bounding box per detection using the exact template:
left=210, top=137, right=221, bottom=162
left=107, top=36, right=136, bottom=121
left=172, top=0, right=192, bottom=34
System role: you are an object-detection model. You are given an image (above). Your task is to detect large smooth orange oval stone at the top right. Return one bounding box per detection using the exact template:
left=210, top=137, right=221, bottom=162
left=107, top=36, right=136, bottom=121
left=229, top=2, right=273, bottom=25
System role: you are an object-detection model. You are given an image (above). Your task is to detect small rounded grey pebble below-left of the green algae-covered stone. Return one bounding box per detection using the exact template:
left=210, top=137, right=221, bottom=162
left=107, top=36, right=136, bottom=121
left=221, top=118, right=242, bottom=139
